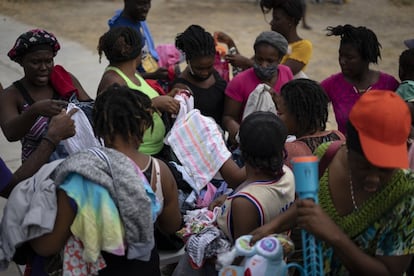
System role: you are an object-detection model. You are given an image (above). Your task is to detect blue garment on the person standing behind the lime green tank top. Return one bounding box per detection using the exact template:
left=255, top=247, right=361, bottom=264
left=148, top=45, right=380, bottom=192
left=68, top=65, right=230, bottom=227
left=108, top=10, right=159, bottom=61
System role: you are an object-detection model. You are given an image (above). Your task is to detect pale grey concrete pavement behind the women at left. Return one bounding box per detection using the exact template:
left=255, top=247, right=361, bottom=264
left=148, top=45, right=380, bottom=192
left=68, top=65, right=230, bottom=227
left=0, top=14, right=106, bottom=276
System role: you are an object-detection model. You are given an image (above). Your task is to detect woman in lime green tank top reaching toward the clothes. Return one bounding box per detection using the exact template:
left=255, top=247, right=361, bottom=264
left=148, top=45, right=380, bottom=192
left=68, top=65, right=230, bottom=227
left=97, top=27, right=180, bottom=155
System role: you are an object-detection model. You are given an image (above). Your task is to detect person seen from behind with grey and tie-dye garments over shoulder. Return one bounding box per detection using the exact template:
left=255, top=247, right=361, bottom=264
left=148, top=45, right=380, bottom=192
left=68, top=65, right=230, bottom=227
left=30, top=84, right=181, bottom=276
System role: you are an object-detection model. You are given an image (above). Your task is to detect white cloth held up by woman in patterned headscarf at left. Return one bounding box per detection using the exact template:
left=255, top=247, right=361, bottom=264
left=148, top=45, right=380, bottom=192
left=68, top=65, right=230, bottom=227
left=62, top=103, right=101, bottom=155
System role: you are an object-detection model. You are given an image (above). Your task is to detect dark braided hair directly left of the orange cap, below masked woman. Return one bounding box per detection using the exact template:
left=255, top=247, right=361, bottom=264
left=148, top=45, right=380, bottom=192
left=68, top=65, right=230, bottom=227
left=280, top=79, right=329, bottom=137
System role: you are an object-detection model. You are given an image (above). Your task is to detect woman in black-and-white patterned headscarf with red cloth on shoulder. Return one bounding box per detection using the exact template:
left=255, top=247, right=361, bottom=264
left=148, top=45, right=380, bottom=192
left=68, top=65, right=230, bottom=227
left=0, top=29, right=90, bottom=162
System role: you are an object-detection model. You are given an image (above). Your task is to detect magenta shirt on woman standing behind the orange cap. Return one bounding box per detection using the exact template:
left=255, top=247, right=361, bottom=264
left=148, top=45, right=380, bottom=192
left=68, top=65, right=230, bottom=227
left=321, top=72, right=399, bottom=135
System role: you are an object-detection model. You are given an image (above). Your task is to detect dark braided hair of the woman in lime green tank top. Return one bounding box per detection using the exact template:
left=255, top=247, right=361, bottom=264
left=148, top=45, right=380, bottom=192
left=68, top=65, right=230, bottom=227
left=98, top=26, right=143, bottom=63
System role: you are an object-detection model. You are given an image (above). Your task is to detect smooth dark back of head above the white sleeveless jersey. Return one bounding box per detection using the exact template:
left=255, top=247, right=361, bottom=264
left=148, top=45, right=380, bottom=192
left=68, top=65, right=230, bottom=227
left=239, top=111, right=287, bottom=174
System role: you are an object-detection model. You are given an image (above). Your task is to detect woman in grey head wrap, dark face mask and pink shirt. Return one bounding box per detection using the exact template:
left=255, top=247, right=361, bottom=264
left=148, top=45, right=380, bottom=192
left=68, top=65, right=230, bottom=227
left=223, top=31, right=293, bottom=145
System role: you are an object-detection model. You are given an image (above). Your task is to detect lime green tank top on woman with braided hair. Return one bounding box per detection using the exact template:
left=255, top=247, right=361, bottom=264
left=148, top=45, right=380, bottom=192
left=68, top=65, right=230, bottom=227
left=105, top=66, right=165, bottom=155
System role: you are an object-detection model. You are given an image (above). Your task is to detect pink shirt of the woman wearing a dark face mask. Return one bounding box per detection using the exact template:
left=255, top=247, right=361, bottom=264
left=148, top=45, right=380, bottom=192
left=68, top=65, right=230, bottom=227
left=225, top=64, right=293, bottom=119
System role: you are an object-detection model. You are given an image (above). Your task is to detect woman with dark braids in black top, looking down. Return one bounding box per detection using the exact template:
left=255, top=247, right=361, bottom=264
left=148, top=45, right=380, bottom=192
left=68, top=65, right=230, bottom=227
left=172, top=25, right=226, bottom=125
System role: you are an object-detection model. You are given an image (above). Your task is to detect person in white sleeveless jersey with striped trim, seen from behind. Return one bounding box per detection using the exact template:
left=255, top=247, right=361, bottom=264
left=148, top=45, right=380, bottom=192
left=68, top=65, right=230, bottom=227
left=173, top=111, right=295, bottom=276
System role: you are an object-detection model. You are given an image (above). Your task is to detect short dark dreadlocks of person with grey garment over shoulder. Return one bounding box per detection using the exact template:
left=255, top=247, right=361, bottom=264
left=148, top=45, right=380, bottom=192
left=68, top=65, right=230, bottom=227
left=92, top=83, right=155, bottom=144
